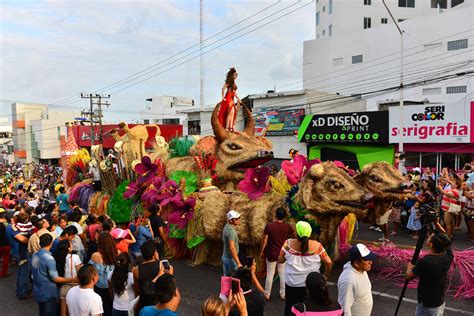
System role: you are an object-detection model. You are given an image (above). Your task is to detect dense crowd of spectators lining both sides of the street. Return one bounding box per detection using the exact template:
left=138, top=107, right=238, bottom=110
left=0, top=163, right=474, bottom=316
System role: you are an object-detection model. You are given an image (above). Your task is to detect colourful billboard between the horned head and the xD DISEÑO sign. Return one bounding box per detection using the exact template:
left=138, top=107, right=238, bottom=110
left=254, top=109, right=304, bottom=136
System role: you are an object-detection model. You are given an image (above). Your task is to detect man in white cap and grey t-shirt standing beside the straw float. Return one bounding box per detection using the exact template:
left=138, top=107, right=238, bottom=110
left=222, top=210, right=242, bottom=276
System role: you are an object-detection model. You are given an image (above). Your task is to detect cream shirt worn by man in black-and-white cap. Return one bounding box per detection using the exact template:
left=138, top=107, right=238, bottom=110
left=337, top=262, right=373, bottom=316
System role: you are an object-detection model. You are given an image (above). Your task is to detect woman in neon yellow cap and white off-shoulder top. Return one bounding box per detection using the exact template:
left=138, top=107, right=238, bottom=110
left=278, top=221, right=332, bottom=316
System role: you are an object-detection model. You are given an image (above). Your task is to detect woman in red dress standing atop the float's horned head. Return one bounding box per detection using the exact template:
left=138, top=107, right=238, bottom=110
left=219, top=67, right=240, bottom=132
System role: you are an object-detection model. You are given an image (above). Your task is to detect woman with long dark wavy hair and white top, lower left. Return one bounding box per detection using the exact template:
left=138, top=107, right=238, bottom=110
left=108, top=252, right=135, bottom=316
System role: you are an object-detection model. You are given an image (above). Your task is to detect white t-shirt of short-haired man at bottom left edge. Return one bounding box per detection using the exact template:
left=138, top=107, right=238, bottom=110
left=66, top=286, right=104, bottom=316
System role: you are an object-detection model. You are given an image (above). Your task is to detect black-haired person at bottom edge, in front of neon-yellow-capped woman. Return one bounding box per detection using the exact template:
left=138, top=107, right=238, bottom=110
left=291, top=272, right=343, bottom=316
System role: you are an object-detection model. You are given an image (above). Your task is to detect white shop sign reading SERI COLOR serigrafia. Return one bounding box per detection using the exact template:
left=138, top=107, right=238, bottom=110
left=389, top=103, right=474, bottom=143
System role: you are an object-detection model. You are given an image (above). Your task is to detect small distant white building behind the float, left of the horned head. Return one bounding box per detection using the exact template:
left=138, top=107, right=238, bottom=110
left=140, top=96, right=195, bottom=127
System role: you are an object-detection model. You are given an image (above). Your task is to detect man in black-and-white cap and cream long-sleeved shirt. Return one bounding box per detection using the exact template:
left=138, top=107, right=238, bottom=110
left=337, top=244, right=377, bottom=316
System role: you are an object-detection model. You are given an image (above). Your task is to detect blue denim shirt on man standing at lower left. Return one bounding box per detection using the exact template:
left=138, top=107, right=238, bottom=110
left=31, top=248, right=59, bottom=302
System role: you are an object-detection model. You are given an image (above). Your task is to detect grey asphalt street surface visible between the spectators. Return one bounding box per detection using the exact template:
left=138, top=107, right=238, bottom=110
left=0, top=224, right=474, bottom=316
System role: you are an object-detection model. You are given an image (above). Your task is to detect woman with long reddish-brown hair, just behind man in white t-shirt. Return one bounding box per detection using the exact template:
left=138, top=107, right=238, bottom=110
left=89, top=232, right=117, bottom=316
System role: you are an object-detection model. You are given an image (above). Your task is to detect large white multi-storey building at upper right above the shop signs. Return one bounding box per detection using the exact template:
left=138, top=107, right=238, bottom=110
left=303, top=0, right=474, bottom=110
